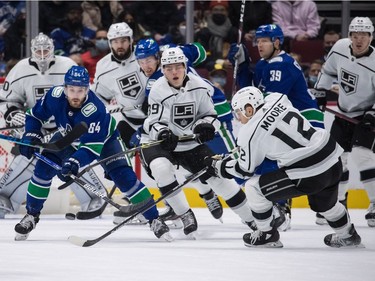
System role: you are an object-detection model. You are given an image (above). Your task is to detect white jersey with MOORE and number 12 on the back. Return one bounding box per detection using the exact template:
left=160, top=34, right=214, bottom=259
left=226, top=93, right=343, bottom=179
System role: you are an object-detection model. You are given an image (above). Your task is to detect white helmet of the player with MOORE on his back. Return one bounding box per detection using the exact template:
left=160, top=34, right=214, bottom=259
left=232, top=86, right=264, bottom=119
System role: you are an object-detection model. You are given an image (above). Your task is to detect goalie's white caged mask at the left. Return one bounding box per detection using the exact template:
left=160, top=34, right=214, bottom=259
left=30, top=32, right=55, bottom=72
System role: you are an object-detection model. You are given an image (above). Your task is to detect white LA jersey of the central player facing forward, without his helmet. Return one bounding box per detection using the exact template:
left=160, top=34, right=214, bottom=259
left=141, top=73, right=220, bottom=151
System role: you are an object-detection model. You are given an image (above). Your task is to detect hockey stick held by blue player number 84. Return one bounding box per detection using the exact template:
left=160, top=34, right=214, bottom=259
left=34, top=152, right=153, bottom=216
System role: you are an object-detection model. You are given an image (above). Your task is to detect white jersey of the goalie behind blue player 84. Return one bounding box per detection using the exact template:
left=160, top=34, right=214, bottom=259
left=0, top=56, right=76, bottom=111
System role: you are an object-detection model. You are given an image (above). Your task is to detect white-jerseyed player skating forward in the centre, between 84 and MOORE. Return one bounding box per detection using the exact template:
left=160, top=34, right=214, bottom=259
left=141, top=48, right=258, bottom=236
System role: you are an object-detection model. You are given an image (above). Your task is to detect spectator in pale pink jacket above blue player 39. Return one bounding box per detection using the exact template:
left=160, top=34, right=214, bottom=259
left=272, top=0, right=320, bottom=51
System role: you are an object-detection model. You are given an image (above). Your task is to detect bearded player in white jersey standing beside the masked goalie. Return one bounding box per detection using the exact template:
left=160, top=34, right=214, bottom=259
left=91, top=22, right=147, bottom=147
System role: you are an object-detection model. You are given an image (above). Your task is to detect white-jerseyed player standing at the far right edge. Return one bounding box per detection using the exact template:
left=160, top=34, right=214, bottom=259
left=315, top=17, right=375, bottom=227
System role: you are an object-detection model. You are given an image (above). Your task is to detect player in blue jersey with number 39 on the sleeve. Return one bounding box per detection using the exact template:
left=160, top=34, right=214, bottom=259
left=228, top=24, right=324, bottom=225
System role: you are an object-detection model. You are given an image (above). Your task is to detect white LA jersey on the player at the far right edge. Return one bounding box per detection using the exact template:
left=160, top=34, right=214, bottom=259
left=315, top=38, right=375, bottom=117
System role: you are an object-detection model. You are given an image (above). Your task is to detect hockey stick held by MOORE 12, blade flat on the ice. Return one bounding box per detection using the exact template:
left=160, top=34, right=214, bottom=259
left=68, top=167, right=207, bottom=247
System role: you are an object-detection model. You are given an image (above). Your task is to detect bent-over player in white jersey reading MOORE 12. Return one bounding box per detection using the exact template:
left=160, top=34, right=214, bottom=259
left=205, top=86, right=361, bottom=248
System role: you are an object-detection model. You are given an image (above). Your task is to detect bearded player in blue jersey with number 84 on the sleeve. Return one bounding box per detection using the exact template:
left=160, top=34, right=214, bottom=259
left=15, top=66, right=171, bottom=240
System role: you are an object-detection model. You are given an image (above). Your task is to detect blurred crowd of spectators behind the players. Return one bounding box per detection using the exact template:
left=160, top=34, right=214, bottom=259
left=0, top=0, right=374, bottom=92
